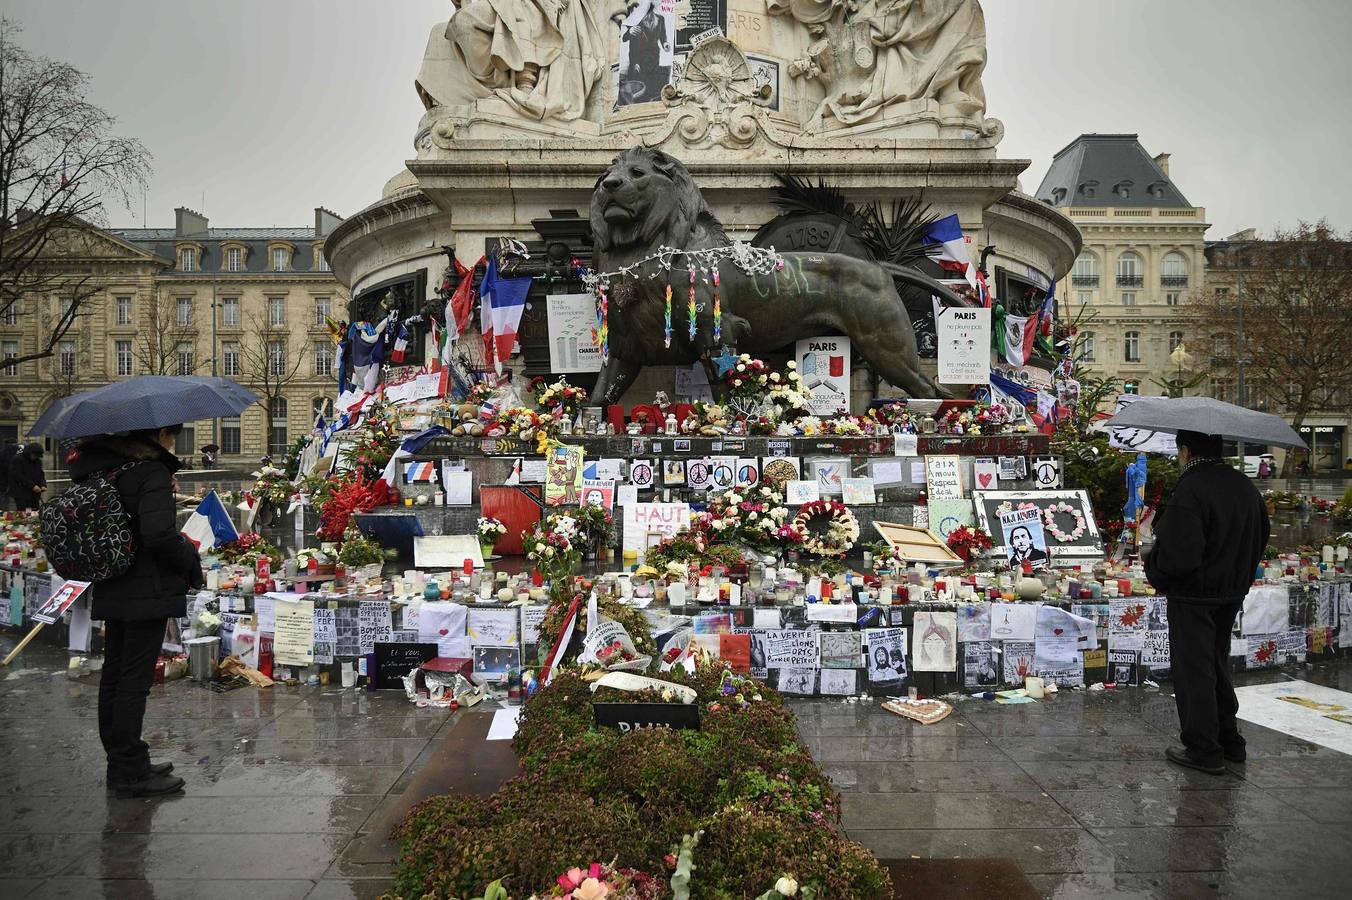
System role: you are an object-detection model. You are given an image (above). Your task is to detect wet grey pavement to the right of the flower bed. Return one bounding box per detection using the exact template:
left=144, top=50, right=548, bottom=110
left=794, top=664, right=1352, bottom=899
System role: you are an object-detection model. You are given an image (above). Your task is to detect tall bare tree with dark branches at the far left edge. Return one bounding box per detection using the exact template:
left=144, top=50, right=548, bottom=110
left=0, top=18, right=150, bottom=362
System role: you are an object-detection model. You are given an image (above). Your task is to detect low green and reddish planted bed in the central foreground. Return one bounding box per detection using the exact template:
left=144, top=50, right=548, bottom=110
left=393, top=665, right=891, bottom=900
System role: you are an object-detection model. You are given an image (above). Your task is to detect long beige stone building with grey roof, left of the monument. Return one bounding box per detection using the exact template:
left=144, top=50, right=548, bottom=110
left=0, top=208, right=347, bottom=466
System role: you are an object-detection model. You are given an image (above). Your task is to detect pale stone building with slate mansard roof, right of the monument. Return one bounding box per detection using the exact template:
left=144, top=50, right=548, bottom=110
left=1037, top=134, right=1224, bottom=395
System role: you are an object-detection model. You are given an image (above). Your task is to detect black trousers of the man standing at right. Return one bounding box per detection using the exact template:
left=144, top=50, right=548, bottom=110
left=1168, top=600, right=1244, bottom=766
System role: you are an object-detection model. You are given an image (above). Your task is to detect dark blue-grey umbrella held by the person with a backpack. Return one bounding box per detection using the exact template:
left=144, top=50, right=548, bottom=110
left=28, top=376, right=258, bottom=438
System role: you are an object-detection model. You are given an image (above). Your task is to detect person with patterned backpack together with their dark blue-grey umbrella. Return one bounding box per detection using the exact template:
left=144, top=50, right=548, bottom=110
left=31, top=376, right=257, bottom=799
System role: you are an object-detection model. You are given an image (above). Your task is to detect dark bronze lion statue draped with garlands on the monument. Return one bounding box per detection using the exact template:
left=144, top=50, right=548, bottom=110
left=589, top=147, right=964, bottom=404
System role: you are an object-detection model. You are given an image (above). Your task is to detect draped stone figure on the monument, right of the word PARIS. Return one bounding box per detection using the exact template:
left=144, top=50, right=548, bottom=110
left=765, top=0, right=986, bottom=131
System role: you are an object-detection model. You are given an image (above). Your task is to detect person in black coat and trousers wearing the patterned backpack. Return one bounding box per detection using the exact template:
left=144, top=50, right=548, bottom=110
left=69, top=426, right=203, bottom=797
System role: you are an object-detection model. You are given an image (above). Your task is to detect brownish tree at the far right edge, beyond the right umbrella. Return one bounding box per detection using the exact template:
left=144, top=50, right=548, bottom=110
left=1201, top=222, right=1352, bottom=459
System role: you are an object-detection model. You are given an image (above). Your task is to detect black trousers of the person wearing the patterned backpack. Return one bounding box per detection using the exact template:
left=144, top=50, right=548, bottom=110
left=99, top=619, right=166, bottom=784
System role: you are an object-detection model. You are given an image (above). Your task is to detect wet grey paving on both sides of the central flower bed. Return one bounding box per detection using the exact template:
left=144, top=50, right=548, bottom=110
left=0, top=634, right=1352, bottom=900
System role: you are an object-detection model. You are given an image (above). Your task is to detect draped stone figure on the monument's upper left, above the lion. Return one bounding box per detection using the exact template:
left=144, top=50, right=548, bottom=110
left=418, top=0, right=623, bottom=122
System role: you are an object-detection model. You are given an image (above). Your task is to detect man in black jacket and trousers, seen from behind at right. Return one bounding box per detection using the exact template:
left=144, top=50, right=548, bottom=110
left=1145, top=431, right=1270, bottom=774
